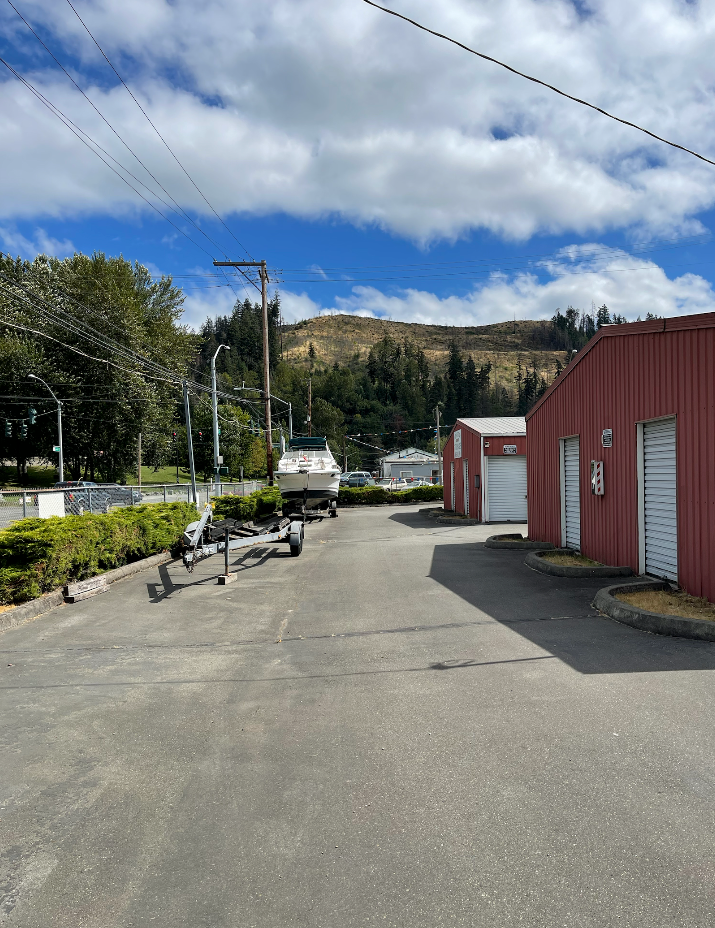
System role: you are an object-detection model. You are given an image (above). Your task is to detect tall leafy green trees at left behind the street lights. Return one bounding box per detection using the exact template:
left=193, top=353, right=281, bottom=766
left=0, top=254, right=265, bottom=482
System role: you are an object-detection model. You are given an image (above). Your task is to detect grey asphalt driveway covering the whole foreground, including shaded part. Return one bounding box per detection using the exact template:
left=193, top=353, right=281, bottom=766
left=0, top=507, right=715, bottom=928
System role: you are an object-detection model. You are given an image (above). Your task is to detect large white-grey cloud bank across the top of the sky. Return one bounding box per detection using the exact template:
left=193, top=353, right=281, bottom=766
left=0, top=0, right=715, bottom=242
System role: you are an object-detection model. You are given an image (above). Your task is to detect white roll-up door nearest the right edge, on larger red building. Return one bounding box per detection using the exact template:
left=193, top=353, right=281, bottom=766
left=643, top=419, right=678, bottom=580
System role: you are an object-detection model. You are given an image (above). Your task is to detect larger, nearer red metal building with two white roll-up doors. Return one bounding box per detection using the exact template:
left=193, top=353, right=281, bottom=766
left=526, top=313, right=715, bottom=600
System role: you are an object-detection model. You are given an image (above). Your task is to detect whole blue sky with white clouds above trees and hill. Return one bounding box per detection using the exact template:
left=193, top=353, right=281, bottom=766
left=0, top=0, right=715, bottom=325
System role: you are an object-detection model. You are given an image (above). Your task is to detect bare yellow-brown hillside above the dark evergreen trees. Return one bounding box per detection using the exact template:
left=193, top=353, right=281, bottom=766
left=283, top=315, right=565, bottom=384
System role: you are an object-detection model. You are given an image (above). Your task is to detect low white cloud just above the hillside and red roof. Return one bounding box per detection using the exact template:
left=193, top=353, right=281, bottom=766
left=281, top=245, right=715, bottom=326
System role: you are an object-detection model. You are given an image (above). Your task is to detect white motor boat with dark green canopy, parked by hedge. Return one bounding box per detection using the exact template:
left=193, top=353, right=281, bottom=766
left=274, top=437, right=340, bottom=514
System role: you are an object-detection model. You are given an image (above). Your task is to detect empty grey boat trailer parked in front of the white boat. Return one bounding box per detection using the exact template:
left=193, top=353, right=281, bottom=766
left=183, top=503, right=305, bottom=577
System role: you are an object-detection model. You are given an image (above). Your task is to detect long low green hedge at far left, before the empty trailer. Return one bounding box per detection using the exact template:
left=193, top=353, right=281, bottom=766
left=0, top=503, right=197, bottom=605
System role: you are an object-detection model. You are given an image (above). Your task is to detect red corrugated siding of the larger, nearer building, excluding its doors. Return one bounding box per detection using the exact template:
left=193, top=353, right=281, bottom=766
left=526, top=316, right=715, bottom=600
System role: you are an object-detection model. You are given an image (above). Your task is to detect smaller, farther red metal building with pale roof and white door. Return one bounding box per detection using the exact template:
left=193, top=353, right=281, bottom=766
left=442, top=416, right=526, bottom=522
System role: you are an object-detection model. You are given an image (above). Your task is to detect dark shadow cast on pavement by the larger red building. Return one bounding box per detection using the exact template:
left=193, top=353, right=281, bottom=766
left=429, top=543, right=715, bottom=674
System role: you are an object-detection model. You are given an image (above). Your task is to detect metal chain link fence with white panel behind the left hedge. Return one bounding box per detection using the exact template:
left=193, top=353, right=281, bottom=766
left=0, top=480, right=265, bottom=528
